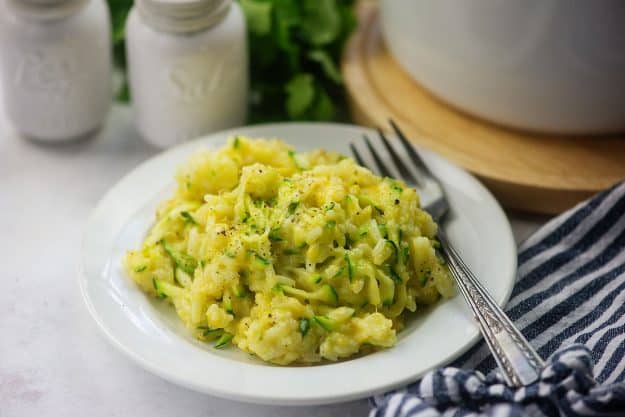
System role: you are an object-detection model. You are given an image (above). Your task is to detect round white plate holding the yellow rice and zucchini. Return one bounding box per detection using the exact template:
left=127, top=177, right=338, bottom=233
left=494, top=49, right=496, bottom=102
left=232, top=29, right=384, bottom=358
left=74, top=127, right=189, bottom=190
left=79, top=123, right=516, bottom=405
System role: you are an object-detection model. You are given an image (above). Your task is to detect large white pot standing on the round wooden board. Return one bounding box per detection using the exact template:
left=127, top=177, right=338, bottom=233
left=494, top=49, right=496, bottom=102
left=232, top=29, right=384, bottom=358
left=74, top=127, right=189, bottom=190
left=380, top=0, right=625, bottom=133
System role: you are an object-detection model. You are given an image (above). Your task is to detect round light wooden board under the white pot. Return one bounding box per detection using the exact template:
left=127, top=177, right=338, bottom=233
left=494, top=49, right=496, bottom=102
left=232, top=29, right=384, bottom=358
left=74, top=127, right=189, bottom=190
left=342, top=2, right=625, bottom=213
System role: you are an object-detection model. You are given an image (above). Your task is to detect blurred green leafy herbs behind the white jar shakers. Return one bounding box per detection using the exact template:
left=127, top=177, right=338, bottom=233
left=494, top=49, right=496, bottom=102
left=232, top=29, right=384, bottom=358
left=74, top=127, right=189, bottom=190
left=107, top=0, right=356, bottom=123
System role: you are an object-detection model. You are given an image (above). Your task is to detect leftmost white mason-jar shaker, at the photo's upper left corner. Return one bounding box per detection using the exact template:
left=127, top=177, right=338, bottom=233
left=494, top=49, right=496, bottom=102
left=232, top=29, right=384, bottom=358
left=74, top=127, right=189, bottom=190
left=0, top=0, right=112, bottom=141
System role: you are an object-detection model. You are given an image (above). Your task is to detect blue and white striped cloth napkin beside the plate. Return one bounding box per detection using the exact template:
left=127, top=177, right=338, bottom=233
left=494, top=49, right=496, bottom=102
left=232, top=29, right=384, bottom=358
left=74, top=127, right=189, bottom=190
left=370, top=183, right=625, bottom=417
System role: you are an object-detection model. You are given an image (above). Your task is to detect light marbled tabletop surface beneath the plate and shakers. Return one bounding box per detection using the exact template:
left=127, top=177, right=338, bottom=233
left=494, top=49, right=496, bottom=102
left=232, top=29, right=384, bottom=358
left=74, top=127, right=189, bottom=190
left=0, top=106, right=545, bottom=417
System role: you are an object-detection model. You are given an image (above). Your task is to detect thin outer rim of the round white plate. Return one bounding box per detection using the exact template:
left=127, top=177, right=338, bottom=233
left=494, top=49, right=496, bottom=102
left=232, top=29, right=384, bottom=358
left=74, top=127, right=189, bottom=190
left=77, top=122, right=517, bottom=406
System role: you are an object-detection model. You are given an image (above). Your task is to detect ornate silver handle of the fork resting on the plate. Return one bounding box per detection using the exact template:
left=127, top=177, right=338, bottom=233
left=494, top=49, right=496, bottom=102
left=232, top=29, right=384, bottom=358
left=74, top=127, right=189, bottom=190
left=438, top=230, right=544, bottom=387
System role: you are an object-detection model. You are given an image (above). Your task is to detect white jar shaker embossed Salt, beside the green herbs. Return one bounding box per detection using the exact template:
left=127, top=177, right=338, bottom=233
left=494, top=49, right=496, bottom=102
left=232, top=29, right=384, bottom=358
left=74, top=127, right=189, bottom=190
left=126, top=0, right=248, bottom=148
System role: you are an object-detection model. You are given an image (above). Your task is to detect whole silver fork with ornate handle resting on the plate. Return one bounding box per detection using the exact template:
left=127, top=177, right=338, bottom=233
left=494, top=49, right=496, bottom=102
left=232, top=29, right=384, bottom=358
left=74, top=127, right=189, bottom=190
left=350, top=120, right=544, bottom=387
